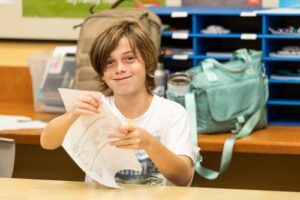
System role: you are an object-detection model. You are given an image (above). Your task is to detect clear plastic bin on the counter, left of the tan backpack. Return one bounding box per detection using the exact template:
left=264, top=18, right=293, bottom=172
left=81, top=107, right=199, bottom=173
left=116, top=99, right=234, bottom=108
left=27, top=53, right=75, bottom=113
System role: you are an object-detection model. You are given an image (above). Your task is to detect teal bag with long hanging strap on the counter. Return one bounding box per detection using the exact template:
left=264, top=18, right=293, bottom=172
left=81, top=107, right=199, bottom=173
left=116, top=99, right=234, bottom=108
left=166, top=49, right=268, bottom=179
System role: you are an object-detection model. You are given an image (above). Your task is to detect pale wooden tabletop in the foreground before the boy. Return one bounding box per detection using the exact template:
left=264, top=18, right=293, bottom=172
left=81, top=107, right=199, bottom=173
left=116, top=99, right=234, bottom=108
left=0, top=178, right=300, bottom=200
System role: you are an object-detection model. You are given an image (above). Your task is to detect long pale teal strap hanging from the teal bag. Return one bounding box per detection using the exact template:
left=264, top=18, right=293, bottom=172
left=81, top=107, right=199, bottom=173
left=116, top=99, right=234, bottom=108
left=185, top=93, right=261, bottom=180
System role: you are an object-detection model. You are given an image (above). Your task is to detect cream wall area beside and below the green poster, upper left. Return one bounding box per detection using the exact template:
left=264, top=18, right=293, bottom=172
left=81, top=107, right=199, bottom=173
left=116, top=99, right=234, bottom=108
left=0, top=0, right=82, bottom=40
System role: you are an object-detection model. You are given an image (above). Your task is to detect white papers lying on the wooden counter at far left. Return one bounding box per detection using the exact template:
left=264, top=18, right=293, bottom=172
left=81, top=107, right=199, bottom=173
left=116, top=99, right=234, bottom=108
left=0, top=115, right=47, bottom=131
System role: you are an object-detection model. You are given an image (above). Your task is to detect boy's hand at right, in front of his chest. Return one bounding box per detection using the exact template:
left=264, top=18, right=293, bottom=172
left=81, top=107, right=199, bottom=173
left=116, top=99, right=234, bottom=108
left=107, top=124, right=152, bottom=150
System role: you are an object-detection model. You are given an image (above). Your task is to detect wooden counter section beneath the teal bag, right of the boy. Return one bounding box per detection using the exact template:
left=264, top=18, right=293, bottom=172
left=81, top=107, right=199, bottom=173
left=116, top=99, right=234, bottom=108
left=198, top=126, right=300, bottom=155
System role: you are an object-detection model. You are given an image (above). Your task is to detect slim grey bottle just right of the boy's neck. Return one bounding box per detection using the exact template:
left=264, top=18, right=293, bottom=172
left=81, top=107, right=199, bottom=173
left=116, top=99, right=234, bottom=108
left=153, top=62, right=167, bottom=97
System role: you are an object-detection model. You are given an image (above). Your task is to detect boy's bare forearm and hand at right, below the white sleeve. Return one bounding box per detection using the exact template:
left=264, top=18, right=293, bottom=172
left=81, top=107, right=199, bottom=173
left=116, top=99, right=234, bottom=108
left=108, top=125, right=193, bottom=186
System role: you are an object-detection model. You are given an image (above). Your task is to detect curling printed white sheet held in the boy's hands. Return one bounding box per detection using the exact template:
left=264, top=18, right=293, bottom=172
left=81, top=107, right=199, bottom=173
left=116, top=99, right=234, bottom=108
left=59, top=88, right=142, bottom=188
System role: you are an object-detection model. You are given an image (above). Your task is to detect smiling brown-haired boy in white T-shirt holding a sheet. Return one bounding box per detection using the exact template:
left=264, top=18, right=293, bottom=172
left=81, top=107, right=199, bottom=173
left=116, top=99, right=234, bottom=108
left=41, top=21, right=195, bottom=186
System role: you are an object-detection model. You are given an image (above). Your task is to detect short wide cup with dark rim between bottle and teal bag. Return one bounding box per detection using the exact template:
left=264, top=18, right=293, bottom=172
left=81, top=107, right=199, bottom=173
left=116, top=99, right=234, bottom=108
left=168, top=72, right=192, bottom=95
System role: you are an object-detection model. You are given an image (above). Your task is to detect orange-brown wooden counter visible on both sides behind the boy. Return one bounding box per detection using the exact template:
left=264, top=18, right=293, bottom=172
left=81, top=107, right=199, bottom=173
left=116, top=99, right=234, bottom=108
left=0, top=103, right=300, bottom=155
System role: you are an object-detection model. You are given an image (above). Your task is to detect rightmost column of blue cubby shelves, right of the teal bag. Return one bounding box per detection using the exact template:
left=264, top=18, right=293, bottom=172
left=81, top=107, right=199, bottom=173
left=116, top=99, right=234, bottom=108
left=262, top=13, right=300, bottom=126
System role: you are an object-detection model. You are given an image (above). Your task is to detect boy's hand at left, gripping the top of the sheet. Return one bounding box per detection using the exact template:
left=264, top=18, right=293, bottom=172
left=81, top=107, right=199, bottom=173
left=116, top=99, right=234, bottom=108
left=69, top=92, right=100, bottom=118
